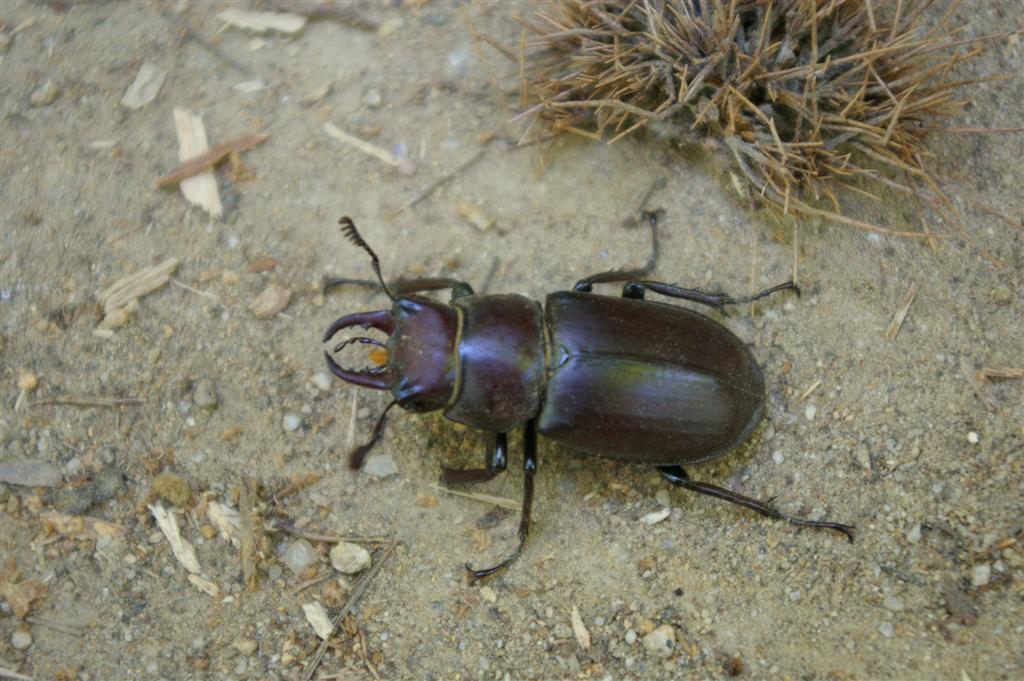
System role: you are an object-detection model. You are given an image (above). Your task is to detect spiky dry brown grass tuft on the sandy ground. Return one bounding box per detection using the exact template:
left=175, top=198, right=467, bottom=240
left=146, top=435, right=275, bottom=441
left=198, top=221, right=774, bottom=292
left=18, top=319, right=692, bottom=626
left=516, top=0, right=1011, bottom=238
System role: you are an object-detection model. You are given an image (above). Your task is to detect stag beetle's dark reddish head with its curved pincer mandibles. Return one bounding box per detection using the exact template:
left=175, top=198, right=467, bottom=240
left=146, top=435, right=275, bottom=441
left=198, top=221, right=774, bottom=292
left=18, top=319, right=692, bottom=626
left=324, top=296, right=459, bottom=412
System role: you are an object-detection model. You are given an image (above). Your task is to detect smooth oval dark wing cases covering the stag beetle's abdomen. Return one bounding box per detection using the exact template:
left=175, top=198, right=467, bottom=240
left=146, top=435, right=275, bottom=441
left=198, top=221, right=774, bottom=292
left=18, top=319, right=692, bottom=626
left=539, top=292, right=764, bottom=464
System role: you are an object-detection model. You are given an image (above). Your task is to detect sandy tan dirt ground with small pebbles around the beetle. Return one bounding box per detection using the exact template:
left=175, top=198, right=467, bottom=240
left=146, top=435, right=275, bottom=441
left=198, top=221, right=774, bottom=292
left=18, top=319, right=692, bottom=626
left=0, top=0, right=1024, bottom=681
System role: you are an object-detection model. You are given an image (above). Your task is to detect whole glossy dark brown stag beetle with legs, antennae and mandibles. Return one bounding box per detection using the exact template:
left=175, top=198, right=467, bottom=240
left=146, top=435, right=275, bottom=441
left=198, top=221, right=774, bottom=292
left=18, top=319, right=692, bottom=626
left=324, top=212, right=853, bottom=579
